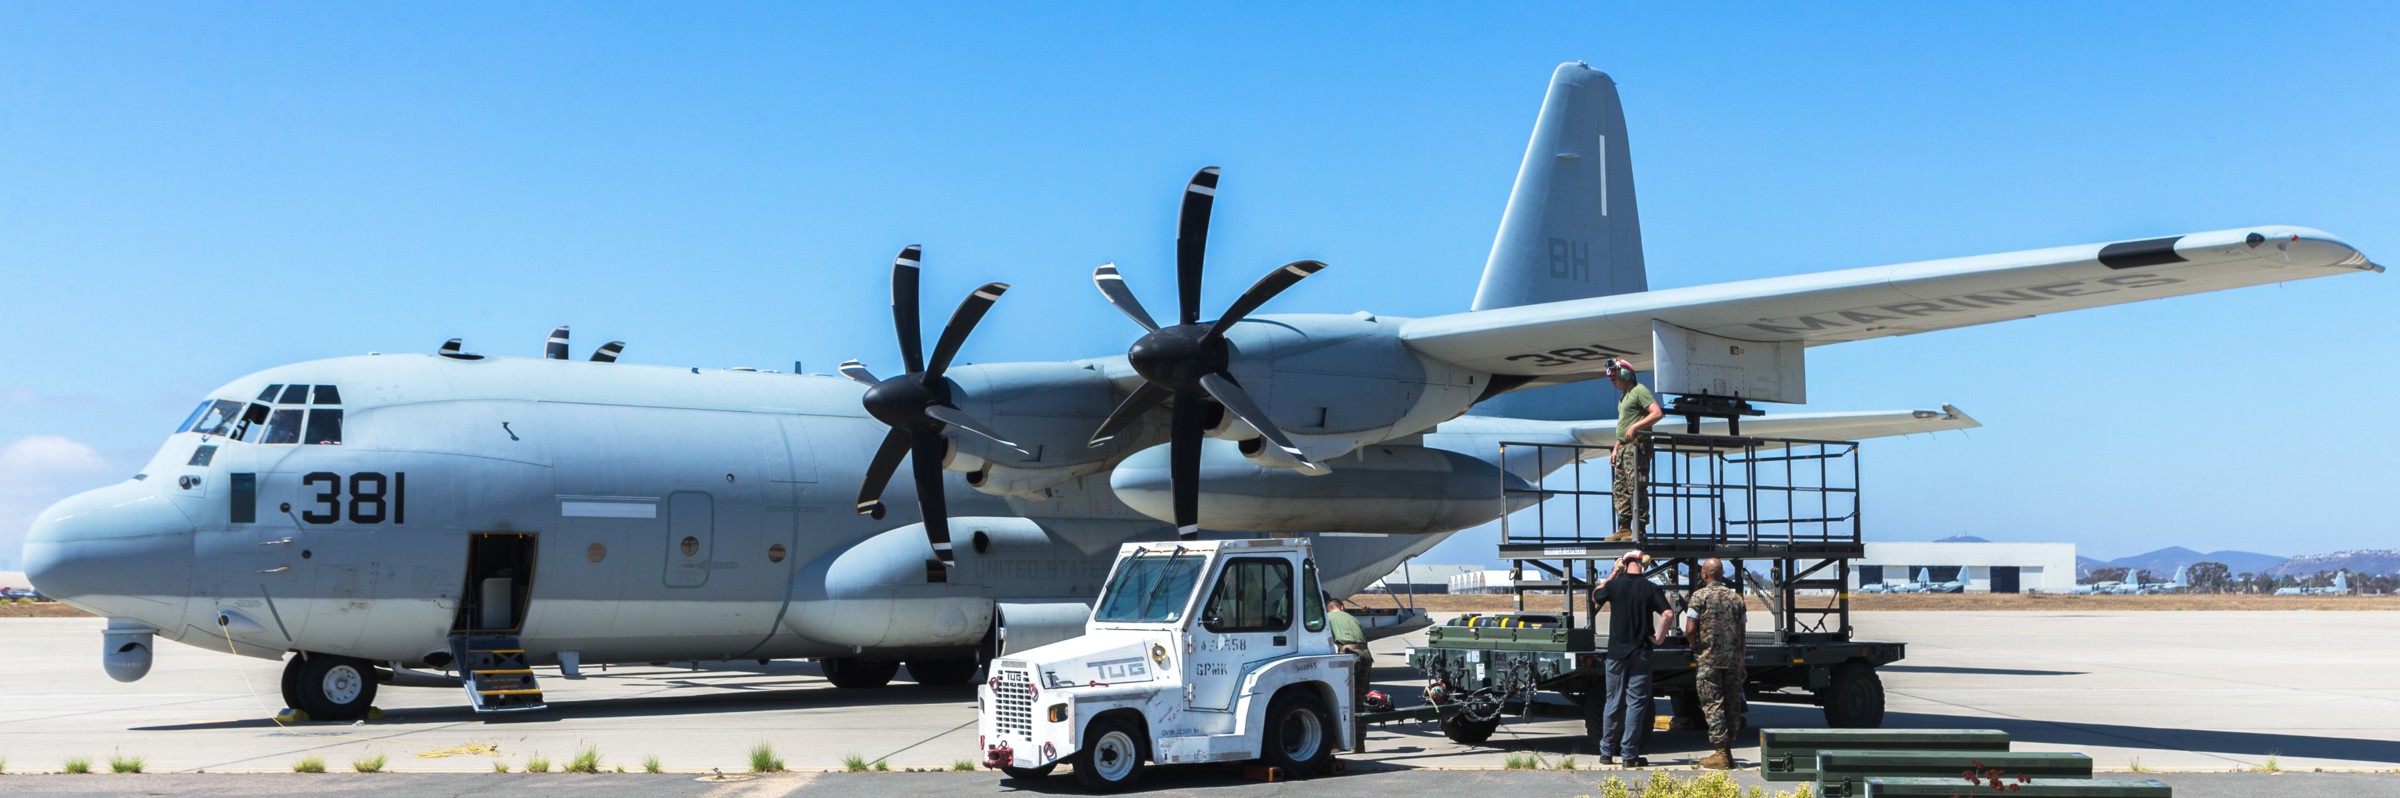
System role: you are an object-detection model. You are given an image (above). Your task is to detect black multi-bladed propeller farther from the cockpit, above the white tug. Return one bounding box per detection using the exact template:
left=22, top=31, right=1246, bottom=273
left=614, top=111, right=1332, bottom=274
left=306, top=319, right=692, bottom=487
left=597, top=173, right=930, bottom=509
left=1092, top=166, right=1325, bottom=541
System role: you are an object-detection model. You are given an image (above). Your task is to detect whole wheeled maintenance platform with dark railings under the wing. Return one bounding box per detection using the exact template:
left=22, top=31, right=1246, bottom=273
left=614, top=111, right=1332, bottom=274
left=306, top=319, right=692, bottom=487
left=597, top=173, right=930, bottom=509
left=1366, top=423, right=1908, bottom=743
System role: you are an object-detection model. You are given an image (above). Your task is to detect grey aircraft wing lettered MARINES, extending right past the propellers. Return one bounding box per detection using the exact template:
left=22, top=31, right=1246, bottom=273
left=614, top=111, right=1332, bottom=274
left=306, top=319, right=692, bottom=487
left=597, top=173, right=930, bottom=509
left=1399, top=226, right=2383, bottom=374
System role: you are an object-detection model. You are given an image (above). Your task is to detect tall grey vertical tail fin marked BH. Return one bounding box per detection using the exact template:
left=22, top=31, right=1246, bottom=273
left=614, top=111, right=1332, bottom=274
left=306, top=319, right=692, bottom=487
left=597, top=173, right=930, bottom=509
left=1474, top=62, right=1649, bottom=310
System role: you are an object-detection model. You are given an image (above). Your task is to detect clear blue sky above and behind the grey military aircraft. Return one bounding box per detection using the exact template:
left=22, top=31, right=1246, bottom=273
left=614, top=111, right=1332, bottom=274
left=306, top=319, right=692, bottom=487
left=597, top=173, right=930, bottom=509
left=0, top=2, right=2400, bottom=562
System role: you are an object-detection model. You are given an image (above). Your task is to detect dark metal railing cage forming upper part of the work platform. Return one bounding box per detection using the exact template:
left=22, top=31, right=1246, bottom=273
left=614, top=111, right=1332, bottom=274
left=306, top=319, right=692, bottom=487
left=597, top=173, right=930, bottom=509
left=1500, top=433, right=1865, bottom=644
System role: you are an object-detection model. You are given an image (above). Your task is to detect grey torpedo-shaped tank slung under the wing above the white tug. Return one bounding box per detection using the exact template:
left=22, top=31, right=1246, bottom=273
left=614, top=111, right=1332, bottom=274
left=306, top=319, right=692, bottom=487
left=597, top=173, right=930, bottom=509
left=1109, top=440, right=1529, bottom=534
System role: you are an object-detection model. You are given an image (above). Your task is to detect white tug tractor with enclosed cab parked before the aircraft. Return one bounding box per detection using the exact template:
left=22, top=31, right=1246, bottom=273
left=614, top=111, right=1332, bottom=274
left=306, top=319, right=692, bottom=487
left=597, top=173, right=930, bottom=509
left=977, top=541, right=1358, bottom=791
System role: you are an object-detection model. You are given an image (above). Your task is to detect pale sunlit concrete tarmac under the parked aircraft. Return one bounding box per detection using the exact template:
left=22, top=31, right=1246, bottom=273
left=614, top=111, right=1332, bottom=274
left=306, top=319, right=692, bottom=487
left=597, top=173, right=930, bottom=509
left=0, top=611, right=2400, bottom=793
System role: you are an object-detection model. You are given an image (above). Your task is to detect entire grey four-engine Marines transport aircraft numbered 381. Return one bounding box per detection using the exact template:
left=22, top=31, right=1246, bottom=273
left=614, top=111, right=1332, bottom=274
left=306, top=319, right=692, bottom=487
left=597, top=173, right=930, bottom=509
left=26, top=62, right=2381, bottom=719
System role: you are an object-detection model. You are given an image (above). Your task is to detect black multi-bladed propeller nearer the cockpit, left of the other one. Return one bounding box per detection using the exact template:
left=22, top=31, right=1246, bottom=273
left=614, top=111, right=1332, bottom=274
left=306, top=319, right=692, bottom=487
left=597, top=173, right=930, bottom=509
left=840, top=245, right=1025, bottom=565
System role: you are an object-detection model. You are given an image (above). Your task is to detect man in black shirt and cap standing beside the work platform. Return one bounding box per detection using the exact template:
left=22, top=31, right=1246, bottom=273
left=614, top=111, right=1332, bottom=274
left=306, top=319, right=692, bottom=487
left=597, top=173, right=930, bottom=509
left=1584, top=550, right=1675, bottom=767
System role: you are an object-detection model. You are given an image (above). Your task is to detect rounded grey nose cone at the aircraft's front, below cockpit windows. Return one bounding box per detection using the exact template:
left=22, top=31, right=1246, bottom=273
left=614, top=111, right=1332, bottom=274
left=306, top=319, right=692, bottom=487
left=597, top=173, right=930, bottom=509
left=24, top=481, right=192, bottom=625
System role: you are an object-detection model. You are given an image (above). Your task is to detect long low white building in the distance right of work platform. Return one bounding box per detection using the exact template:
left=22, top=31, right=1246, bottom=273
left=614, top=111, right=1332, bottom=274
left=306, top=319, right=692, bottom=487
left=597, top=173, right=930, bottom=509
left=1850, top=543, right=2076, bottom=594
